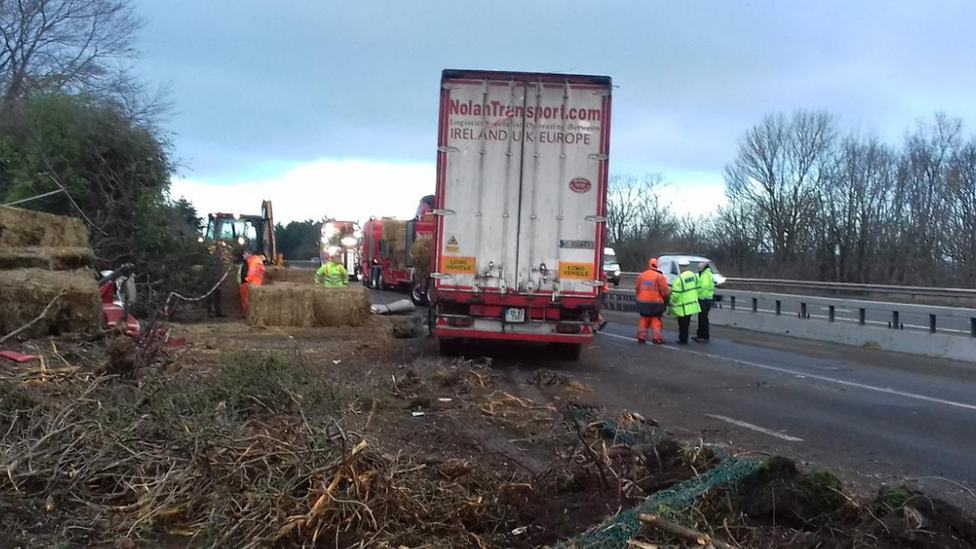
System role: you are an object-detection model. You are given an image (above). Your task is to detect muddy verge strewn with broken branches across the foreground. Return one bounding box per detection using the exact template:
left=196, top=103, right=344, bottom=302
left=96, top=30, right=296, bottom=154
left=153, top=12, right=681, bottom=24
left=0, top=318, right=976, bottom=549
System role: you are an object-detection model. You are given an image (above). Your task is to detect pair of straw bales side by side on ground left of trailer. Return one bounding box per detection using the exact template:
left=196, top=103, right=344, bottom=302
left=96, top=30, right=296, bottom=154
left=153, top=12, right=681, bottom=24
left=247, top=282, right=370, bottom=328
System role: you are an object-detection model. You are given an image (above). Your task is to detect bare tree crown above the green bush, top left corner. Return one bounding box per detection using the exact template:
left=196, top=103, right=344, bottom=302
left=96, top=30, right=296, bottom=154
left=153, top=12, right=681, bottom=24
left=0, top=0, right=141, bottom=107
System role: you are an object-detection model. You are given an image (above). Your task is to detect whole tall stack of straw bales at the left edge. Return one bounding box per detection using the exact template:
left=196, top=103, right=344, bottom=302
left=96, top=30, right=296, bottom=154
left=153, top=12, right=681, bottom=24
left=0, top=206, right=102, bottom=335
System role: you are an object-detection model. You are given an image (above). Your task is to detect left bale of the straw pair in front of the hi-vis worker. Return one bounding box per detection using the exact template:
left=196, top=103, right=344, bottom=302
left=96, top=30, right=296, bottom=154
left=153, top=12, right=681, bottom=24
left=247, top=282, right=315, bottom=328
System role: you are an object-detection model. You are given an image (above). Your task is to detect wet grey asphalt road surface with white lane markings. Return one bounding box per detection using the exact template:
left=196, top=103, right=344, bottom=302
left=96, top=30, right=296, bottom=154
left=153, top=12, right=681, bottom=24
left=376, top=288, right=976, bottom=511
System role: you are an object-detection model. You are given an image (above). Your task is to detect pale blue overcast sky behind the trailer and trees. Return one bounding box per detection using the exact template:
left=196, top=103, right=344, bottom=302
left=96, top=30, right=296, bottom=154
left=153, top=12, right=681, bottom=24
left=138, top=0, right=976, bottom=221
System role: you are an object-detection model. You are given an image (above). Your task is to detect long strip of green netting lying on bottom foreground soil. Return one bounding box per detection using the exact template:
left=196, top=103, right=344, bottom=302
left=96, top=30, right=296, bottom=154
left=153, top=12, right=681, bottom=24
left=556, top=456, right=759, bottom=549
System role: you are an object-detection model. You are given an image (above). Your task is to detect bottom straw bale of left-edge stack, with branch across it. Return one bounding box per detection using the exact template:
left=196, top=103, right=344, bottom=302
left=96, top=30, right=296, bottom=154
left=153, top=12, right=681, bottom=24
left=0, top=269, right=102, bottom=336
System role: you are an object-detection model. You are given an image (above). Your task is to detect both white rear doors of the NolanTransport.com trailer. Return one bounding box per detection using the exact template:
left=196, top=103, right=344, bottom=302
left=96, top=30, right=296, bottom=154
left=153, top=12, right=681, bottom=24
left=436, top=72, right=610, bottom=296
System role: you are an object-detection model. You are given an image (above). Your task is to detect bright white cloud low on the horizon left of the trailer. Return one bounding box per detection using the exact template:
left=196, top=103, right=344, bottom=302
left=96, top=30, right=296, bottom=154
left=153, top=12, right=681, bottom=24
left=170, top=158, right=436, bottom=223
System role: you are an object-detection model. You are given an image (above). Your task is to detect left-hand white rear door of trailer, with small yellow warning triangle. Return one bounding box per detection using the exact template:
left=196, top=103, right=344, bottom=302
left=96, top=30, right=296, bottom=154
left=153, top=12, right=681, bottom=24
left=437, top=79, right=525, bottom=292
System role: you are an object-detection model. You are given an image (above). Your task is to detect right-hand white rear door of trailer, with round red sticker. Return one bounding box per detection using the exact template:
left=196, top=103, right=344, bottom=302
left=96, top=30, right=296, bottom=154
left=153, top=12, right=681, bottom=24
left=518, top=78, right=609, bottom=296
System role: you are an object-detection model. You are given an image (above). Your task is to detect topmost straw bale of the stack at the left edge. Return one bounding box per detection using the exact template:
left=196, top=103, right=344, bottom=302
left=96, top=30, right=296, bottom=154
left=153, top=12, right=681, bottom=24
left=0, top=206, right=88, bottom=249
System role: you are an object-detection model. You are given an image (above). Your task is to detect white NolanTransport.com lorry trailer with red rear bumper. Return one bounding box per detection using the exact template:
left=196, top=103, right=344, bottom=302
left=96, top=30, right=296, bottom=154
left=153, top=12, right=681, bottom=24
left=430, top=70, right=612, bottom=358
